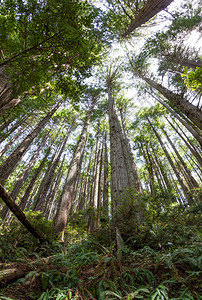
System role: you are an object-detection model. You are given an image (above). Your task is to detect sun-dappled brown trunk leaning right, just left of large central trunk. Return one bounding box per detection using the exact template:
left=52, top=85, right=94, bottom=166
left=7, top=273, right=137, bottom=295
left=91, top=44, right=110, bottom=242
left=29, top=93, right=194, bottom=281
left=54, top=106, right=94, bottom=239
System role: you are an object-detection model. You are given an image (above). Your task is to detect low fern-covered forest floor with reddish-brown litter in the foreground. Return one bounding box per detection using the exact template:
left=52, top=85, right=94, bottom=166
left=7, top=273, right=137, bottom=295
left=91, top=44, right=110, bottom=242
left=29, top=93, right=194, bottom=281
left=0, top=239, right=202, bottom=300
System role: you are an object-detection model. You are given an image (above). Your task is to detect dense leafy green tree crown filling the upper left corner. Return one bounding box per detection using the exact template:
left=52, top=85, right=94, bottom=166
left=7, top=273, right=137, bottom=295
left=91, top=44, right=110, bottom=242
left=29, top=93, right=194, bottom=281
left=0, top=0, right=102, bottom=112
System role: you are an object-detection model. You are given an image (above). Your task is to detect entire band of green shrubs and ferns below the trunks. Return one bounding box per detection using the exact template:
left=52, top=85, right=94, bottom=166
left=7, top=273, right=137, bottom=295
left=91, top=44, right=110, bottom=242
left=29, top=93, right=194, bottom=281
left=0, top=199, right=202, bottom=300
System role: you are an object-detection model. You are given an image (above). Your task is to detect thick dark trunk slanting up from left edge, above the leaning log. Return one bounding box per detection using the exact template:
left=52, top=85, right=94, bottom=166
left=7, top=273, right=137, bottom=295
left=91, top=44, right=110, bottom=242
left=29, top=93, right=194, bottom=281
left=0, top=104, right=60, bottom=184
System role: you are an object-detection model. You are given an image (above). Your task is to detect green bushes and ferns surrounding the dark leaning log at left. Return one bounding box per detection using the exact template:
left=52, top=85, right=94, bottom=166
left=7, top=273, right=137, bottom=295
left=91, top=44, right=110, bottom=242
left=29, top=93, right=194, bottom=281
left=0, top=211, right=61, bottom=262
